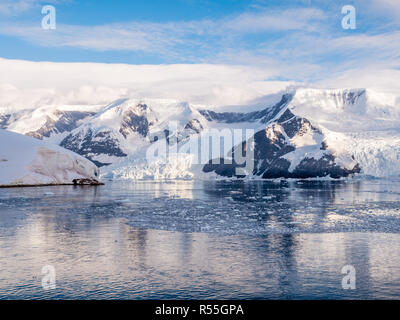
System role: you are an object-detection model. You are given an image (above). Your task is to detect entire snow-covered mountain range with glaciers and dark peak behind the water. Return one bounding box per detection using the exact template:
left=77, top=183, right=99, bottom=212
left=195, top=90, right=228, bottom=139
left=0, top=88, right=400, bottom=179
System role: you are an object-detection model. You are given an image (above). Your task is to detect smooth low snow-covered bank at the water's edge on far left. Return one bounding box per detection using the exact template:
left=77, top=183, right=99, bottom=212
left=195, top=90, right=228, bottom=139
left=0, top=130, right=99, bottom=187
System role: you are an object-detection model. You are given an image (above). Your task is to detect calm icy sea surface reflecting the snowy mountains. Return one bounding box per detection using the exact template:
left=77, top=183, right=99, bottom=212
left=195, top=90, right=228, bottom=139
left=0, top=180, right=400, bottom=299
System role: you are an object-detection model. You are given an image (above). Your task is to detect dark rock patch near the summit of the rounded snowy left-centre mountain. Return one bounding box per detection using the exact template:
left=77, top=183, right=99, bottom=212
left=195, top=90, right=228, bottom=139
left=119, top=104, right=153, bottom=139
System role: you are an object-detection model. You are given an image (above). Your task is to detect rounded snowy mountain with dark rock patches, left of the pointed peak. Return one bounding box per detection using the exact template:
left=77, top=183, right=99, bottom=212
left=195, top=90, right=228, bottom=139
left=60, top=99, right=198, bottom=166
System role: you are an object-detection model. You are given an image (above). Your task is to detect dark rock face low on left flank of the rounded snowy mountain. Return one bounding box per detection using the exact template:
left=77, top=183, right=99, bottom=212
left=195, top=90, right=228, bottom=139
left=60, top=129, right=127, bottom=167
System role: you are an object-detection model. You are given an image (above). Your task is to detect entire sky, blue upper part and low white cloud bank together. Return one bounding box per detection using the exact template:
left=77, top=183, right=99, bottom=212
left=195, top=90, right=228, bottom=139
left=0, top=0, right=400, bottom=104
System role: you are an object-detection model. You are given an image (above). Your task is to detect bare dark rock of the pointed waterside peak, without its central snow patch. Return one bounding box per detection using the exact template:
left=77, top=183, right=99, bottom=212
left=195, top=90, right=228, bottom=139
left=203, top=110, right=361, bottom=179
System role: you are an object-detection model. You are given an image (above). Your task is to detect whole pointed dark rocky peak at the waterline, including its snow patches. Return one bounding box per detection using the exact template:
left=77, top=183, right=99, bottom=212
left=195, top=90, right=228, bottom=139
left=203, top=109, right=360, bottom=179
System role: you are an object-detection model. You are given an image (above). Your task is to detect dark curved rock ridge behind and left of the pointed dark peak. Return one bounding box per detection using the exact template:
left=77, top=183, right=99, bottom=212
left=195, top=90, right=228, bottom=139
left=199, top=93, right=293, bottom=123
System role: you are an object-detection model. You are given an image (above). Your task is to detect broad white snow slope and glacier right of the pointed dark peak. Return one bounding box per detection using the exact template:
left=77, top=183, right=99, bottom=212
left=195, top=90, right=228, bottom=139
left=289, top=89, right=400, bottom=177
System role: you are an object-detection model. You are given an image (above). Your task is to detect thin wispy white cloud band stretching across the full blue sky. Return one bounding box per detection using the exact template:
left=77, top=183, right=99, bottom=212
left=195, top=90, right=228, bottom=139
left=0, top=0, right=400, bottom=73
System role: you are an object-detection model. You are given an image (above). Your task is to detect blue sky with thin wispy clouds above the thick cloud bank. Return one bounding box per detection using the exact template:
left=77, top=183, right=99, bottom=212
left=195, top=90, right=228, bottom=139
left=0, top=0, right=400, bottom=81
